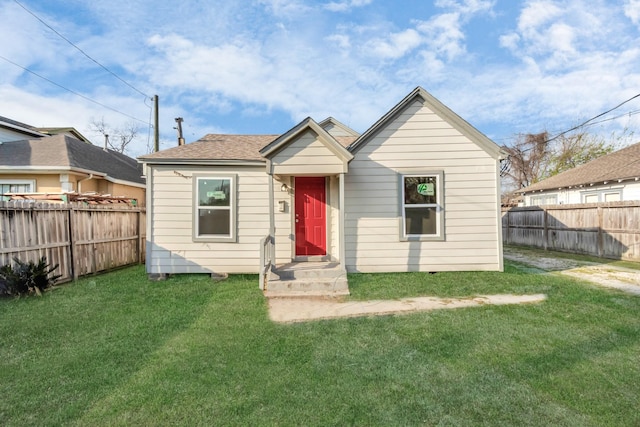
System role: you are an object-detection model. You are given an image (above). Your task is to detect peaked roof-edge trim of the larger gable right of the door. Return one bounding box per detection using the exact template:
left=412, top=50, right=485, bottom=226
left=347, top=86, right=503, bottom=159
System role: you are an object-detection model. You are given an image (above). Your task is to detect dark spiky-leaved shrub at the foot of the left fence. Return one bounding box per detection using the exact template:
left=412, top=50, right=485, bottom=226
left=0, top=257, right=61, bottom=295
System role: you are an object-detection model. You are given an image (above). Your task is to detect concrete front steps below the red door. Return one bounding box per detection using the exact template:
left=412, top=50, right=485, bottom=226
left=264, top=262, right=349, bottom=298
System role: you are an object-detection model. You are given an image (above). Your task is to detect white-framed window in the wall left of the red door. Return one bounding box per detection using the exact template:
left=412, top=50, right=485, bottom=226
left=193, top=175, right=236, bottom=242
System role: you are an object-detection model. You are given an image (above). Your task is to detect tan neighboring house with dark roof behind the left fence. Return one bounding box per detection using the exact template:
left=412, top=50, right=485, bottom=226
left=0, top=134, right=146, bottom=204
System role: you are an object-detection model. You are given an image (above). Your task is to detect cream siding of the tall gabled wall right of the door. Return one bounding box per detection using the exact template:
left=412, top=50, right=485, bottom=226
left=345, top=102, right=502, bottom=272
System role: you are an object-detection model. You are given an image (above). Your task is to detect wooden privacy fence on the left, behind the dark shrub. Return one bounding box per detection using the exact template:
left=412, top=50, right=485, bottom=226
left=0, top=201, right=146, bottom=282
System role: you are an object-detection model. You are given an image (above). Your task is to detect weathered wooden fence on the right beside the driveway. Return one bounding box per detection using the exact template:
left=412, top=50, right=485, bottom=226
left=502, top=201, right=640, bottom=261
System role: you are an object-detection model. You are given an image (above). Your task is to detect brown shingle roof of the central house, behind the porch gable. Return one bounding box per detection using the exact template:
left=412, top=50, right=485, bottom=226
left=139, top=134, right=356, bottom=162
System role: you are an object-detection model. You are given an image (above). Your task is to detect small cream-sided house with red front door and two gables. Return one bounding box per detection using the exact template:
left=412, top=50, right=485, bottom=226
left=139, top=87, right=503, bottom=294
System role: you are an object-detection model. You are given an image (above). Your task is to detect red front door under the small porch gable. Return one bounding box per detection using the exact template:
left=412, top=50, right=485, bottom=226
left=295, top=176, right=327, bottom=256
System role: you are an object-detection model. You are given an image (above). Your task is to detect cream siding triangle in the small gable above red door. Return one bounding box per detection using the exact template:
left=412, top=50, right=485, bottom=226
left=271, top=131, right=344, bottom=175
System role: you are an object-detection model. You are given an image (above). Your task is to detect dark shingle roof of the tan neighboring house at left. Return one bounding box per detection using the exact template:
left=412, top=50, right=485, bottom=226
left=0, top=135, right=145, bottom=185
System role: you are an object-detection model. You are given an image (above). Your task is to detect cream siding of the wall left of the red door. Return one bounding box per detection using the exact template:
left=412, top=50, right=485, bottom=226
left=147, top=165, right=269, bottom=273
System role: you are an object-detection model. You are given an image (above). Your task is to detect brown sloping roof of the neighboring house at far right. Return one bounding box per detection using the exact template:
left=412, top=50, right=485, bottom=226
left=518, top=143, right=640, bottom=193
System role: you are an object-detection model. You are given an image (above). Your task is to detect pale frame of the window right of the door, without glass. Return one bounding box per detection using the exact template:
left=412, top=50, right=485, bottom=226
left=398, top=171, right=444, bottom=242
